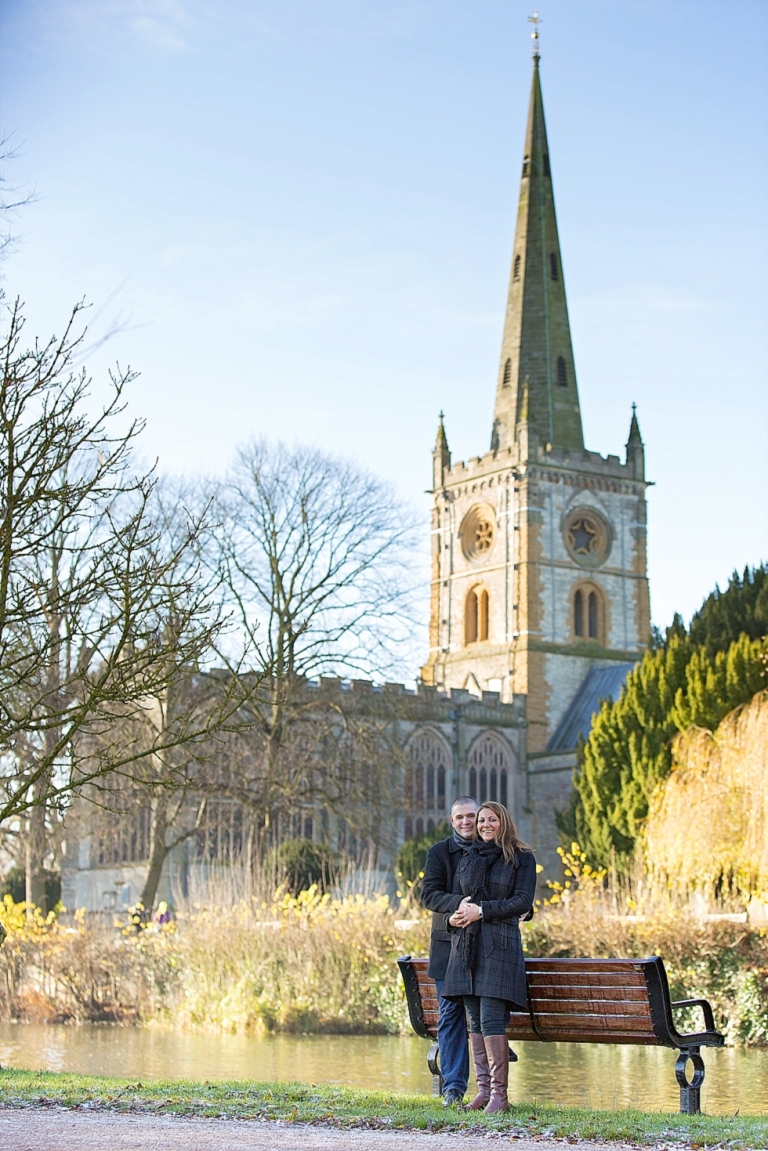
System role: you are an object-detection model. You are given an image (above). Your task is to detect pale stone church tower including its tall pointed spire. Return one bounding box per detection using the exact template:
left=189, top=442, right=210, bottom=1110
left=421, top=49, right=651, bottom=759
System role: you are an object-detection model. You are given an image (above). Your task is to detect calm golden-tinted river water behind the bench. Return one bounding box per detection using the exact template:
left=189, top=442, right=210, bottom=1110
left=0, top=1023, right=768, bottom=1114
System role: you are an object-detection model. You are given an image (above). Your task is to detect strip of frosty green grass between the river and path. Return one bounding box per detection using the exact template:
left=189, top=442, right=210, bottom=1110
left=0, top=1069, right=768, bottom=1149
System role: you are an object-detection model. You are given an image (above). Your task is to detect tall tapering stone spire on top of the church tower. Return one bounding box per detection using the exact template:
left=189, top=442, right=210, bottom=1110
left=494, top=51, right=584, bottom=449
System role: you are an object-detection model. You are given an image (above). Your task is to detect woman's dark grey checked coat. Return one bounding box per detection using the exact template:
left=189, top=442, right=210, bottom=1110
left=442, top=852, right=537, bottom=1011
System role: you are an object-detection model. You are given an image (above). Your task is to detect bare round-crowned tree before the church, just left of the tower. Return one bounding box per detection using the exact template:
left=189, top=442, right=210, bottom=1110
left=211, top=442, right=418, bottom=852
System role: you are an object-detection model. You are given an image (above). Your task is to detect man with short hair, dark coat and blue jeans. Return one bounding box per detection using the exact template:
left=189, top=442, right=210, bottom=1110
left=421, top=795, right=478, bottom=1107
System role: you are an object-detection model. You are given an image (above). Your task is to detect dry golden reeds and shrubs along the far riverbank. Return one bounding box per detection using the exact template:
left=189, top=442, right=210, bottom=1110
left=0, top=883, right=768, bottom=1047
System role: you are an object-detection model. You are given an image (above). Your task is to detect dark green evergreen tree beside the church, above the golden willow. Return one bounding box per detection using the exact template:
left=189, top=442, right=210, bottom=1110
left=571, top=565, right=768, bottom=868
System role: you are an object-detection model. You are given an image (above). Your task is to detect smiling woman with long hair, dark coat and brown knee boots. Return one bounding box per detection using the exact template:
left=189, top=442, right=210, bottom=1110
left=442, top=803, right=537, bottom=1112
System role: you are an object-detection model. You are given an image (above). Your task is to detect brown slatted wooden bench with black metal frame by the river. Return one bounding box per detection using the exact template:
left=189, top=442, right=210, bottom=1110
left=397, top=955, right=724, bottom=1115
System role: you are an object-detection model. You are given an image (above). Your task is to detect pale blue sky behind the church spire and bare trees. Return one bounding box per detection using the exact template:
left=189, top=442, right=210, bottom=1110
left=0, top=0, right=768, bottom=662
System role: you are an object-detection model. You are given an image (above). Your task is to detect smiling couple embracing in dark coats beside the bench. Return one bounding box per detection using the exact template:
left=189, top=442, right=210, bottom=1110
left=421, top=795, right=537, bottom=1112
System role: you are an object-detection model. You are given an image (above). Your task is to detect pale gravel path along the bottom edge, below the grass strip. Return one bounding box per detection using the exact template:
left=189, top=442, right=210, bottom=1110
left=0, top=1107, right=649, bottom=1151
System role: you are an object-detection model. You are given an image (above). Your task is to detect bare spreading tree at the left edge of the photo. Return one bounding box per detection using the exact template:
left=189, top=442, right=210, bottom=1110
left=0, top=304, right=249, bottom=904
